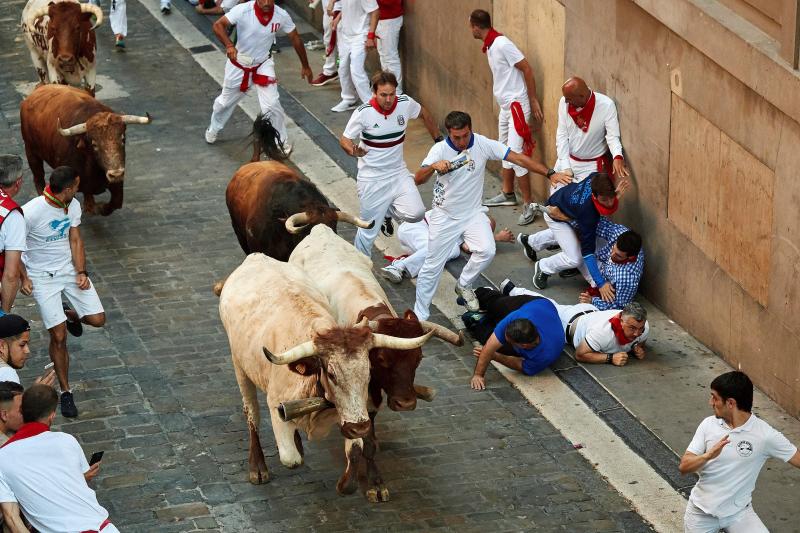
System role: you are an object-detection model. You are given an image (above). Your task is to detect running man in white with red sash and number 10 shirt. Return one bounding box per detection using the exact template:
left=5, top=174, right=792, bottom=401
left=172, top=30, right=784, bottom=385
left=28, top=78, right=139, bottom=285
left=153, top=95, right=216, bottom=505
left=206, top=0, right=312, bottom=154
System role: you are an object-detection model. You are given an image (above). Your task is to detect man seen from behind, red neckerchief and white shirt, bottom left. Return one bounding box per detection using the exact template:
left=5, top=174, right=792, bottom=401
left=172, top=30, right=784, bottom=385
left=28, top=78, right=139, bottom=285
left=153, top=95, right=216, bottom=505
left=0, top=385, right=119, bottom=533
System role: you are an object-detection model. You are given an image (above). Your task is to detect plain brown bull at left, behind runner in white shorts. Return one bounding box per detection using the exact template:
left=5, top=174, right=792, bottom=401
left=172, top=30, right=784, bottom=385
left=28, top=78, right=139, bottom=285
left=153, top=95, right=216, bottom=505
left=19, top=85, right=150, bottom=215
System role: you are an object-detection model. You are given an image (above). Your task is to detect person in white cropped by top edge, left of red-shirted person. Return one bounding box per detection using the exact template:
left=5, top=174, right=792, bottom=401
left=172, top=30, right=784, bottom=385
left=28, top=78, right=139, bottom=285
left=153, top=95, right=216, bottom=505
left=331, top=0, right=379, bottom=113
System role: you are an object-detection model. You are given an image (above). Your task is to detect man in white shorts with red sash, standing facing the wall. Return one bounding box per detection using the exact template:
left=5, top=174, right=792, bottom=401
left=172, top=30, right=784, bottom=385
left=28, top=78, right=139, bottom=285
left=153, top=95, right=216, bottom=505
left=469, top=9, right=544, bottom=226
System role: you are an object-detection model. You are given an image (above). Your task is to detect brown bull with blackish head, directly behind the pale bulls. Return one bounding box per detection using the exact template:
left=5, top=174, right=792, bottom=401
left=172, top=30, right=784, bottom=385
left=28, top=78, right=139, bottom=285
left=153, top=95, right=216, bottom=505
left=225, top=161, right=372, bottom=261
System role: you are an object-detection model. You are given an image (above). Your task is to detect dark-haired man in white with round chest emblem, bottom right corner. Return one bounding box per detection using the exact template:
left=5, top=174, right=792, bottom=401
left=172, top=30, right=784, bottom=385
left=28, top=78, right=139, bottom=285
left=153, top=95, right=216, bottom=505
left=678, top=371, right=800, bottom=533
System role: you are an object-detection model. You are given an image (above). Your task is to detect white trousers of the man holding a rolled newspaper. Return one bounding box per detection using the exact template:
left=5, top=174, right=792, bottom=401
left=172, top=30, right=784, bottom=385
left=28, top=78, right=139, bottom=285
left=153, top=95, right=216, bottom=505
left=414, top=208, right=495, bottom=320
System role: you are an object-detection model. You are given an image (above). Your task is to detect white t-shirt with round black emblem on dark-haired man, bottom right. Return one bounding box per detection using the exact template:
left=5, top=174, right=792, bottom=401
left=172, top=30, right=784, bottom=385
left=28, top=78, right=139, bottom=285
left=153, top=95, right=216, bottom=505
left=686, top=415, right=797, bottom=517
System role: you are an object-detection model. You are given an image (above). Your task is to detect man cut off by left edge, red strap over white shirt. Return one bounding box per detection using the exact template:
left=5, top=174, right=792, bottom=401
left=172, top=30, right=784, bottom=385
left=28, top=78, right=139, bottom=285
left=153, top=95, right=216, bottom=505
left=0, top=155, right=25, bottom=314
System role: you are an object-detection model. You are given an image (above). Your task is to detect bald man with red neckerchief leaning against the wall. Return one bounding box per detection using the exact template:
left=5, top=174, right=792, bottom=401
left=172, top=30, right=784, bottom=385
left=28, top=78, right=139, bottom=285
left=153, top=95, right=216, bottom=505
left=551, top=78, right=629, bottom=185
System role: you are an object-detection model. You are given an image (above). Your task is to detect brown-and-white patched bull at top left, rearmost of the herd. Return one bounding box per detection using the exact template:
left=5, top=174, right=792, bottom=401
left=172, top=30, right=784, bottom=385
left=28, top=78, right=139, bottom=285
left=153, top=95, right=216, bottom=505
left=21, top=0, right=103, bottom=96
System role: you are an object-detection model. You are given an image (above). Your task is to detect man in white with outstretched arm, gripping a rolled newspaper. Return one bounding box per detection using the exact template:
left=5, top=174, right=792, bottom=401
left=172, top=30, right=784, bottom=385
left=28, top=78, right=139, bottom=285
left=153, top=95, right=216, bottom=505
left=414, top=111, right=569, bottom=320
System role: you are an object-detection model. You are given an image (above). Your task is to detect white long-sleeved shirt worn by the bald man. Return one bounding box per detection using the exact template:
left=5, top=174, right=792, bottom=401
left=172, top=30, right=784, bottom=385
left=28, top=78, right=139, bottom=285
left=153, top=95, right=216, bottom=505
left=555, top=91, right=622, bottom=170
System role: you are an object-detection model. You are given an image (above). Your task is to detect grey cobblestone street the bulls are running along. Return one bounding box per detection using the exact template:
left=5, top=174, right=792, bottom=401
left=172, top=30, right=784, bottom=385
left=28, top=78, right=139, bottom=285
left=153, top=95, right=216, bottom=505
left=0, top=0, right=650, bottom=532
